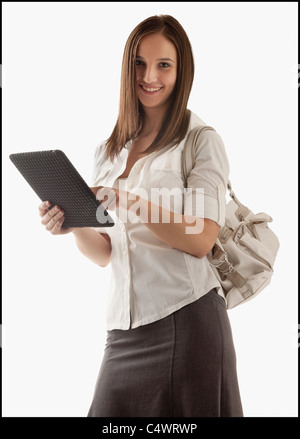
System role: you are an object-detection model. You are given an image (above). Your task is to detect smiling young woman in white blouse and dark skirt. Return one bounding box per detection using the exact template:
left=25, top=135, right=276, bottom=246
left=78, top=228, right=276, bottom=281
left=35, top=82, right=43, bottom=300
left=40, top=15, right=243, bottom=417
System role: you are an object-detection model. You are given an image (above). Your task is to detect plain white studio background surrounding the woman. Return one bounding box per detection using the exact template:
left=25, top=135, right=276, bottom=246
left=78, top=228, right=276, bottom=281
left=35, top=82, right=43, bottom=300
left=2, top=2, right=298, bottom=417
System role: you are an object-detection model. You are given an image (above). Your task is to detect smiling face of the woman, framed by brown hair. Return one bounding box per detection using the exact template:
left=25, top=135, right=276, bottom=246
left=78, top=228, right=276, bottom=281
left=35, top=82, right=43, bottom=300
left=135, top=34, right=177, bottom=112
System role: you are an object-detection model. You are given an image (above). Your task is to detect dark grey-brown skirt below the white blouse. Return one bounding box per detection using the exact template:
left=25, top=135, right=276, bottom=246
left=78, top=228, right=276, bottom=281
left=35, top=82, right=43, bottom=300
left=87, top=289, right=243, bottom=417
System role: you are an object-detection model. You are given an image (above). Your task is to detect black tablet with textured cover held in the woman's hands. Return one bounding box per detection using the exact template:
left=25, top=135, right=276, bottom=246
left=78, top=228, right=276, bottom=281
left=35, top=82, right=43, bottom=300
left=9, top=149, right=114, bottom=228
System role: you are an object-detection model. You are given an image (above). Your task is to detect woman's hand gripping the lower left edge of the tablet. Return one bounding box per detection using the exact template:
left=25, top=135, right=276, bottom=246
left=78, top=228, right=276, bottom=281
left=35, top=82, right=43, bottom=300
left=39, top=201, right=75, bottom=235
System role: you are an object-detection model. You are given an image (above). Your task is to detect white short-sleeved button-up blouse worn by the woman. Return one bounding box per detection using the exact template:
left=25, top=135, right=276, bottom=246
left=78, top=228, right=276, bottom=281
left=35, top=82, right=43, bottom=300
left=91, top=112, right=229, bottom=330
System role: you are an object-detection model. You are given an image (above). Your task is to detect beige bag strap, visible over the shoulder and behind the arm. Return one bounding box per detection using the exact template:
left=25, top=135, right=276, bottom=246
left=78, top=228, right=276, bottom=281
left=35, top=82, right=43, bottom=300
left=181, top=125, right=244, bottom=210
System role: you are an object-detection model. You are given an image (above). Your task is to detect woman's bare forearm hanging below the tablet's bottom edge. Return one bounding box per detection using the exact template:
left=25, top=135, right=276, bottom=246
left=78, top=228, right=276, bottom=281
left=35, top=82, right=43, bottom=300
left=72, top=228, right=111, bottom=267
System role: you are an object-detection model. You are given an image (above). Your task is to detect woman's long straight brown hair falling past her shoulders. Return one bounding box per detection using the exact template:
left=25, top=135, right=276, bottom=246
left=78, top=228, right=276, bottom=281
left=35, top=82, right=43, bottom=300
left=106, top=15, right=194, bottom=164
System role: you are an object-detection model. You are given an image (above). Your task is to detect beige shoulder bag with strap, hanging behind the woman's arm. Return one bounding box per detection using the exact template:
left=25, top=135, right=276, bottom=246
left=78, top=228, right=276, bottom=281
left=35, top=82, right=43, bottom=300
left=182, top=126, right=279, bottom=309
